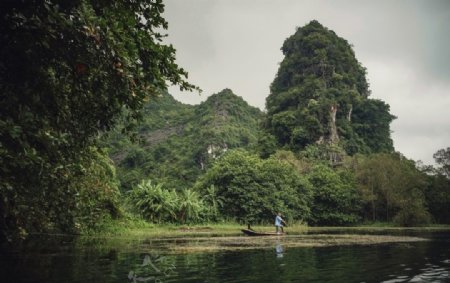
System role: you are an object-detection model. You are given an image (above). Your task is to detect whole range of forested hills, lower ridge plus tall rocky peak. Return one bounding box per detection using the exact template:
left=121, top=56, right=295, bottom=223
left=111, top=21, right=395, bottom=190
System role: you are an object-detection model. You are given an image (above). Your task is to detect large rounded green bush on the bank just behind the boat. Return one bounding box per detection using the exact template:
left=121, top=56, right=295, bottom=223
left=196, top=150, right=311, bottom=223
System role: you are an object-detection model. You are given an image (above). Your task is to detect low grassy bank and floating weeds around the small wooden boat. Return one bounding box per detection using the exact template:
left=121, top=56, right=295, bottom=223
left=68, top=216, right=450, bottom=254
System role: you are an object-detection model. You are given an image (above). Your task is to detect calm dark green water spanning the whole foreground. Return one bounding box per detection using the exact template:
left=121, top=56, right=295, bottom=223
left=0, top=233, right=450, bottom=283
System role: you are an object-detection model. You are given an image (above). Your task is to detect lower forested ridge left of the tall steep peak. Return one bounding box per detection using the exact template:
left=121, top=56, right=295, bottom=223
left=108, top=89, right=262, bottom=190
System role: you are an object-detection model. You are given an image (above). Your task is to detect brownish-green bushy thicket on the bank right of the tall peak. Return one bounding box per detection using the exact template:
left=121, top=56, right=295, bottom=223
left=356, top=154, right=430, bottom=226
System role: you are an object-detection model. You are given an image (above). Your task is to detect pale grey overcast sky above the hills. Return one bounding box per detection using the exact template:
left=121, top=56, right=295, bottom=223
left=163, top=0, right=450, bottom=164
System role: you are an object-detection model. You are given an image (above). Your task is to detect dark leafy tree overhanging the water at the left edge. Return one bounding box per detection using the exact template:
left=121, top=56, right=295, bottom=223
left=0, top=0, right=195, bottom=242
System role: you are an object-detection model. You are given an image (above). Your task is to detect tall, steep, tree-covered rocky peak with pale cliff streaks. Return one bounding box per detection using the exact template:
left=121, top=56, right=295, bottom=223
left=265, top=20, right=395, bottom=154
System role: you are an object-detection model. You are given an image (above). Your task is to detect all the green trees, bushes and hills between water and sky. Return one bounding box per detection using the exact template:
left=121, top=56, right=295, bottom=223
left=0, top=0, right=450, bottom=244
